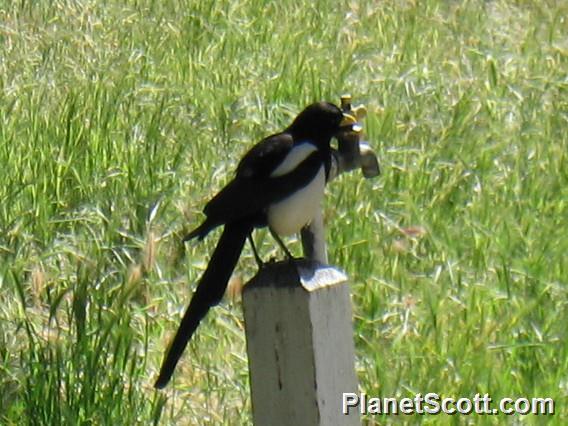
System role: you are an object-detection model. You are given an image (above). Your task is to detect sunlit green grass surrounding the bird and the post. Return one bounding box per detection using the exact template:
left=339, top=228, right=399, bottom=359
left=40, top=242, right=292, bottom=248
left=0, top=0, right=568, bottom=425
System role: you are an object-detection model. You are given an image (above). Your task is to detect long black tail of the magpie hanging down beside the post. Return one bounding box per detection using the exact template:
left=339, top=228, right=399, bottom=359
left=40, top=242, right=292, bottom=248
left=154, top=221, right=253, bottom=389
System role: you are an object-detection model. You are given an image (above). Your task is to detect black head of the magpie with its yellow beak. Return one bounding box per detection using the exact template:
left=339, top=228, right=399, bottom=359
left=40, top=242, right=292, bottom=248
left=288, top=102, right=354, bottom=143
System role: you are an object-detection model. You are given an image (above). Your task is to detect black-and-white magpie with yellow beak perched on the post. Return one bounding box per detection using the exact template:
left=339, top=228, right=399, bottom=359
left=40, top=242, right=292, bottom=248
left=154, top=102, right=353, bottom=389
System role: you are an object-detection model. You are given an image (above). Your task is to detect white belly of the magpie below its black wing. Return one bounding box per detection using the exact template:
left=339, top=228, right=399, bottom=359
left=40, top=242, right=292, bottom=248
left=268, top=166, right=325, bottom=235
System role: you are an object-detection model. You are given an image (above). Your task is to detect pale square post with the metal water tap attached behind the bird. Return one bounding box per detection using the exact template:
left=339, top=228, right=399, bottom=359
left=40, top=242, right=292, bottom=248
left=243, top=98, right=379, bottom=426
